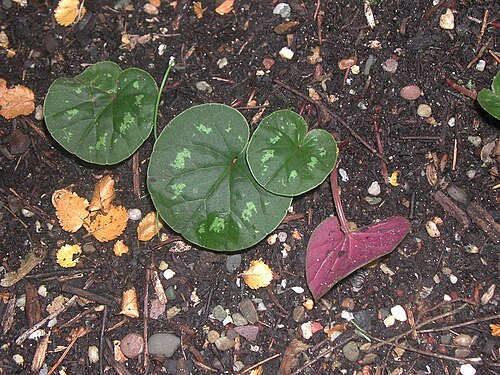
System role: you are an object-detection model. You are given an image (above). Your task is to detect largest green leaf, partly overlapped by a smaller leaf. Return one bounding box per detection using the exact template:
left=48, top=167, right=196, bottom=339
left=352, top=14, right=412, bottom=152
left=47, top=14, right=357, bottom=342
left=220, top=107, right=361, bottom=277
left=148, top=104, right=291, bottom=251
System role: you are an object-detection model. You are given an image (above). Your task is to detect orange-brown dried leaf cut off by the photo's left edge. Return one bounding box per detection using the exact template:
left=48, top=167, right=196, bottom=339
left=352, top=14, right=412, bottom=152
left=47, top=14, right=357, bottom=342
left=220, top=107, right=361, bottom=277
left=0, top=78, right=35, bottom=120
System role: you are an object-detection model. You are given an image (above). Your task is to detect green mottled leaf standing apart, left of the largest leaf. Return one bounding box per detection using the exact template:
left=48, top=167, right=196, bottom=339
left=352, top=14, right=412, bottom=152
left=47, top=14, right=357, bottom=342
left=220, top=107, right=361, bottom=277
left=44, top=61, right=158, bottom=164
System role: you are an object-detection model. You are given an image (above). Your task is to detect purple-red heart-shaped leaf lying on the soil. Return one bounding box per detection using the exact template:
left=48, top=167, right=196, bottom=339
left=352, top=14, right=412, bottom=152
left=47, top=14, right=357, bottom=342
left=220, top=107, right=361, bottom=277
left=306, top=216, right=410, bottom=299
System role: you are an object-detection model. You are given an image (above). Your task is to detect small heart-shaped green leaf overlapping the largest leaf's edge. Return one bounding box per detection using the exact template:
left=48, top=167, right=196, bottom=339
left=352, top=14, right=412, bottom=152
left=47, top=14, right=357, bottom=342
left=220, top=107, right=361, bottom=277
left=247, top=110, right=338, bottom=196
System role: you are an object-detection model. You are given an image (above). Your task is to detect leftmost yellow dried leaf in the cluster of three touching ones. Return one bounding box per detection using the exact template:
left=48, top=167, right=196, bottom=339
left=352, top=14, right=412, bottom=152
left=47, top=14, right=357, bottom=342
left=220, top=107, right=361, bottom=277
left=52, top=189, right=89, bottom=233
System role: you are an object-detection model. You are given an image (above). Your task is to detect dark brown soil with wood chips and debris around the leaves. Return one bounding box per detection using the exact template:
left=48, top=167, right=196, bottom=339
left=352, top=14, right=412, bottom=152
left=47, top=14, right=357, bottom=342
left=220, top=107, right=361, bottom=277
left=0, top=0, right=500, bottom=374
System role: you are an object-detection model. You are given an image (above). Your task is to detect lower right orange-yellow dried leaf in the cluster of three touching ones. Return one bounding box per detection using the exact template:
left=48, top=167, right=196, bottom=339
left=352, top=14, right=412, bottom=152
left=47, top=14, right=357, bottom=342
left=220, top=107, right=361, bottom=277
left=88, top=206, right=128, bottom=242
